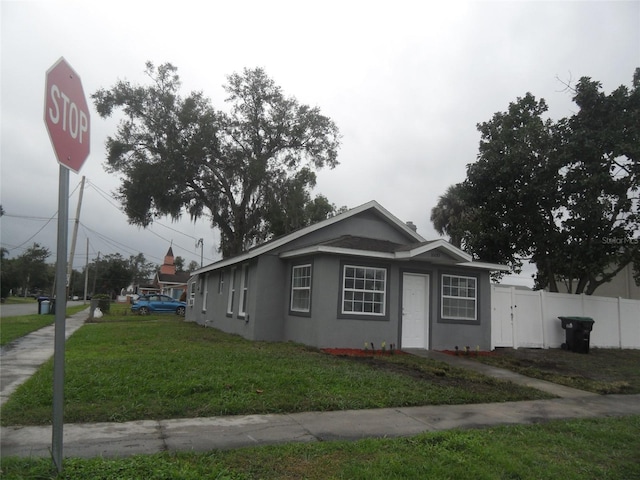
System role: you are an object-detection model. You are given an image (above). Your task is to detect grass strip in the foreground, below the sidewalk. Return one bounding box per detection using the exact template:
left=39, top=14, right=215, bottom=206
left=2, top=416, right=640, bottom=480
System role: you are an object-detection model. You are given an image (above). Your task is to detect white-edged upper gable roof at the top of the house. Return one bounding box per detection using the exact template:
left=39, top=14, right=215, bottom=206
left=193, top=200, right=425, bottom=275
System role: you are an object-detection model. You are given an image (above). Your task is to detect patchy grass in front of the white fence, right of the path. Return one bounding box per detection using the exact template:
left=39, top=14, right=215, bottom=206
left=469, top=348, right=640, bottom=394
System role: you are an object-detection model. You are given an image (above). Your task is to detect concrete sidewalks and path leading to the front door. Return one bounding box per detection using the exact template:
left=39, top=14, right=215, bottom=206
left=0, top=311, right=640, bottom=458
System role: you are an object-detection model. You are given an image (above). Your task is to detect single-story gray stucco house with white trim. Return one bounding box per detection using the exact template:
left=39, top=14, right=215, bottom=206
left=186, top=201, right=505, bottom=350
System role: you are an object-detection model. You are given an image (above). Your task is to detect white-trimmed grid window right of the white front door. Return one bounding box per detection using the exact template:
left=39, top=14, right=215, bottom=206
left=441, top=275, right=478, bottom=320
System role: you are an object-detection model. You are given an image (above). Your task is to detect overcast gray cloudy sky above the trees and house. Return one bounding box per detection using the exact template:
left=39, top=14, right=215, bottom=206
left=0, top=0, right=640, bottom=284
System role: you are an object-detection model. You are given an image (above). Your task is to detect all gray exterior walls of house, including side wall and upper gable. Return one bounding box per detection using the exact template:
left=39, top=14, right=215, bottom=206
left=186, top=206, right=491, bottom=350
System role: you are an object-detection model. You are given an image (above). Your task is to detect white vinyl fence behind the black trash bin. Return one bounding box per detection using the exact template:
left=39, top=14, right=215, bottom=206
left=491, top=285, right=640, bottom=348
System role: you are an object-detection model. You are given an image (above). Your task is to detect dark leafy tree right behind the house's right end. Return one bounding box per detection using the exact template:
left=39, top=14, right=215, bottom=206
left=460, top=93, right=564, bottom=289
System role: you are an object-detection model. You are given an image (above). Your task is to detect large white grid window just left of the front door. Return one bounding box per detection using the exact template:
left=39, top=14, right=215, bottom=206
left=342, top=265, right=387, bottom=316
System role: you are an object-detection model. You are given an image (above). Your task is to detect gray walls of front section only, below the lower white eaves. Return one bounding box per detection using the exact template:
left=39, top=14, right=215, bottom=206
left=283, top=255, right=491, bottom=350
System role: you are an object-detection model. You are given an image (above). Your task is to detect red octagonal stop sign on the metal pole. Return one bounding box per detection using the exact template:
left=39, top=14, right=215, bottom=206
left=44, top=57, right=91, bottom=173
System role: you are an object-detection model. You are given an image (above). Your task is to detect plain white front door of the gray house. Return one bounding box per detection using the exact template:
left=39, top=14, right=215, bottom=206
left=400, top=273, right=429, bottom=348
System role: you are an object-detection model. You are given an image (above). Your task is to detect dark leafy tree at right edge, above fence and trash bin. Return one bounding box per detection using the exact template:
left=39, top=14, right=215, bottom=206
left=559, top=72, right=640, bottom=294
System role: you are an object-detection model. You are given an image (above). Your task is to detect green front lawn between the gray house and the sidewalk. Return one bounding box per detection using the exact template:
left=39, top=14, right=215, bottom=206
left=2, top=316, right=549, bottom=425
